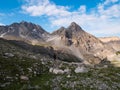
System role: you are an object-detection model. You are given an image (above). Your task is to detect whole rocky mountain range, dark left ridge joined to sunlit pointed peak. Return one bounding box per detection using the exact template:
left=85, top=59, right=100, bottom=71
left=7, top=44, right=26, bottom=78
left=0, top=21, right=115, bottom=64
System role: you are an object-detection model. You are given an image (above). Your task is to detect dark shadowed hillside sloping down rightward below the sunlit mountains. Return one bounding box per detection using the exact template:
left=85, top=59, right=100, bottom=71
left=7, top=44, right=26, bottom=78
left=0, top=38, right=82, bottom=62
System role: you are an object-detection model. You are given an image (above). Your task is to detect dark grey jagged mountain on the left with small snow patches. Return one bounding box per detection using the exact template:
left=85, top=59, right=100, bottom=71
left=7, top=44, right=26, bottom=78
left=0, top=21, right=49, bottom=44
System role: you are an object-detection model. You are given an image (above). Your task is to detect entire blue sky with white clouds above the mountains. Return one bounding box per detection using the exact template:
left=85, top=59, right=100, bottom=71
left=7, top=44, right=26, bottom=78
left=0, top=0, right=120, bottom=37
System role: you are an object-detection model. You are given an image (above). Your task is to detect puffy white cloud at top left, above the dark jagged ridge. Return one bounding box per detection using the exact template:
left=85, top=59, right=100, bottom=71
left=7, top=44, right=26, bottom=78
left=22, top=0, right=70, bottom=16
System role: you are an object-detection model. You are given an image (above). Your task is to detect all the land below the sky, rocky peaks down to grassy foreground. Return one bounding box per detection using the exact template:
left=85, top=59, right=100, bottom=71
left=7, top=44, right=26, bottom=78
left=0, top=22, right=120, bottom=90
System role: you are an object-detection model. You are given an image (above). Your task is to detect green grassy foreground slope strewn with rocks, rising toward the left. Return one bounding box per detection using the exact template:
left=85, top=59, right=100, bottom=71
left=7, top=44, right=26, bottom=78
left=0, top=40, right=120, bottom=90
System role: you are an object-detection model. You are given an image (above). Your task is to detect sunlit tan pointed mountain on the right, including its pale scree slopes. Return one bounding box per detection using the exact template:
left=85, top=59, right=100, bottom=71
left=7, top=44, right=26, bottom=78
left=48, top=22, right=114, bottom=63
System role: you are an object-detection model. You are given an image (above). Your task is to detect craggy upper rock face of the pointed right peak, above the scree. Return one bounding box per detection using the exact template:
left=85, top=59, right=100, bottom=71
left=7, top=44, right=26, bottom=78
left=53, top=22, right=103, bottom=51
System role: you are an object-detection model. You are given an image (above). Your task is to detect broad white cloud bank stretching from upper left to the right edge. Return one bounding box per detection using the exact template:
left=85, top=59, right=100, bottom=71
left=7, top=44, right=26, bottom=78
left=22, top=0, right=120, bottom=35
